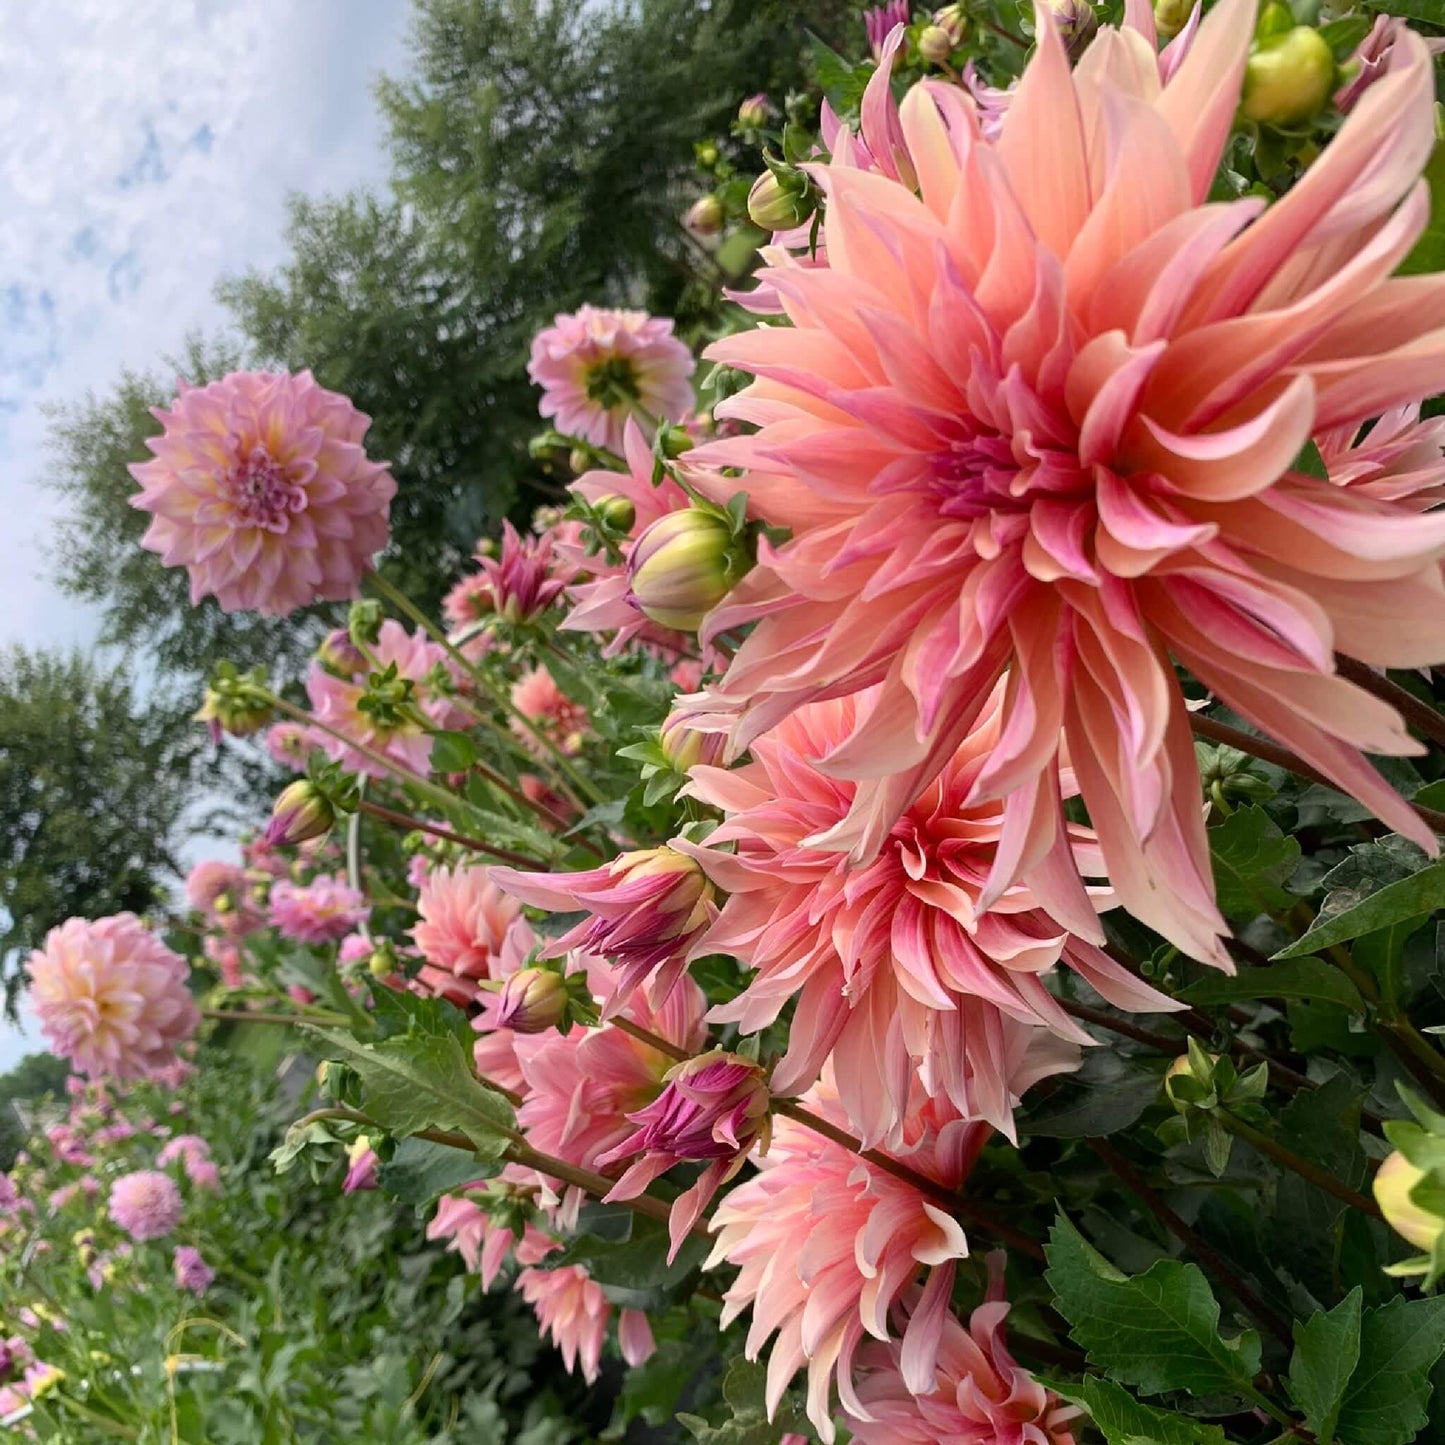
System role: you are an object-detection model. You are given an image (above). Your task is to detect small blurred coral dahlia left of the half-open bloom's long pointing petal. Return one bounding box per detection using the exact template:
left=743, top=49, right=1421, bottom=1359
left=412, top=864, right=536, bottom=1007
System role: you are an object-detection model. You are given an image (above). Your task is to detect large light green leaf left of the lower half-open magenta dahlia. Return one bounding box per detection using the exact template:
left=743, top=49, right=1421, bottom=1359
left=306, top=1027, right=516, bottom=1159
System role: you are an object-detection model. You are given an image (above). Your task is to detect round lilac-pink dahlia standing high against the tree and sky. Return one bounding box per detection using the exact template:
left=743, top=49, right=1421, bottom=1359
left=130, top=371, right=396, bottom=617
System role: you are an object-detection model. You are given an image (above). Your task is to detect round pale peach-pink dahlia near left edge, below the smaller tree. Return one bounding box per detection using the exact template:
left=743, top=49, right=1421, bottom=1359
left=26, top=913, right=201, bottom=1081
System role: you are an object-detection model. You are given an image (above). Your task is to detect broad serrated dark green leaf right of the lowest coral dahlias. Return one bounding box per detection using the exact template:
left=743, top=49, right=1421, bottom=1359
left=1045, top=1212, right=1260, bottom=1399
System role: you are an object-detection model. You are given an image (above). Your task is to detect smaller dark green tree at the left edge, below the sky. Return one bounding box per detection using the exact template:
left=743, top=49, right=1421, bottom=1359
left=0, top=647, right=205, bottom=999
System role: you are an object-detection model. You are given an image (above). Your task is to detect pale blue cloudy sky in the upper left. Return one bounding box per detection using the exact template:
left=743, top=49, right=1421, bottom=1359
left=0, top=0, right=406, bottom=1069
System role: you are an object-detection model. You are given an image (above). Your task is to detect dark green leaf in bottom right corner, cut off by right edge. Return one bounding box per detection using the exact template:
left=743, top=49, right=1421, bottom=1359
left=1335, top=1298, right=1445, bottom=1445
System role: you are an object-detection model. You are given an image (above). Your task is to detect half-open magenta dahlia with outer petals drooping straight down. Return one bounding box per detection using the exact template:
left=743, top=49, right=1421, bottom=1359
left=597, top=1051, right=772, bottom=1263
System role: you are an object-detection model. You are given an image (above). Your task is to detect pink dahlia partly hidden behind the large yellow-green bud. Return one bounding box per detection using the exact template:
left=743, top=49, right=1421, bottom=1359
left=561, top=420, right=692, bottom=657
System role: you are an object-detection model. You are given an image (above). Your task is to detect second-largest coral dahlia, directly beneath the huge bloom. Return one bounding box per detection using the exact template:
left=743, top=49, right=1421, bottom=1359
left=679, top=692, right=1179, bottom=1144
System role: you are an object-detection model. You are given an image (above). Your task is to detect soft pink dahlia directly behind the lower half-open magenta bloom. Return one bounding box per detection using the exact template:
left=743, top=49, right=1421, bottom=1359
left=514, top=978, right=707, bottom=1224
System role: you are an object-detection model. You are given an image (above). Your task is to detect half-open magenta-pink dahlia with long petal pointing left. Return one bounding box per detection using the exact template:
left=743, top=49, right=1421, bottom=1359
left=491, top=847, right=717, bottom=1013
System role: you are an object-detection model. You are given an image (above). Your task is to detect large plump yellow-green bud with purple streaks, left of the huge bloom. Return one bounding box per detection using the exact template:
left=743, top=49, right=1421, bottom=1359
left=627, top=507, right=746, bottom=631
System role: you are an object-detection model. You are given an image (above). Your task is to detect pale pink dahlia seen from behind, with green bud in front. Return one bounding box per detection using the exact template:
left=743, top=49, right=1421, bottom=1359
left=306, top=617, right=468, bottom=777
